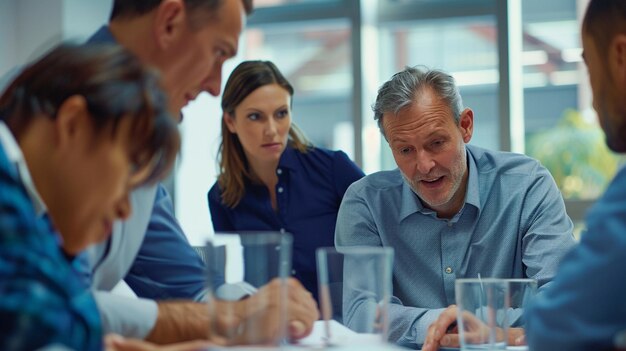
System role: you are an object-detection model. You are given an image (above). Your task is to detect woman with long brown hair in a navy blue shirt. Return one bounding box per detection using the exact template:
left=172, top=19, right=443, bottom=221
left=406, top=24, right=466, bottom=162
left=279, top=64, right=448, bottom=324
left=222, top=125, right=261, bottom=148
left=208, top=61, right=363, bottom=302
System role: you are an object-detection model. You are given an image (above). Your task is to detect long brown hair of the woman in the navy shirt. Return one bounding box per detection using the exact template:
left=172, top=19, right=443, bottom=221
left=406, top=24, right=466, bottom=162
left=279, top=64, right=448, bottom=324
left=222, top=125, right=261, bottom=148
left=217, top=61, right=311, bottom=208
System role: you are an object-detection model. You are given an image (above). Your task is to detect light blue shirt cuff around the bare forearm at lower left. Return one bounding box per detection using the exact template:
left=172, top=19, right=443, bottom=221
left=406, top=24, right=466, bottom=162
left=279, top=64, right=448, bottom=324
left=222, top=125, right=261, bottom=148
left=94, top=291, right=159, bottom=339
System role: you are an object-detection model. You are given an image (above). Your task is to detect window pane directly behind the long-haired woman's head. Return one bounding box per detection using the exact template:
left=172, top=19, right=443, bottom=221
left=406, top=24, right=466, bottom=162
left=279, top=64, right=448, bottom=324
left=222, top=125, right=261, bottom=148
left=244, top=19, right=354, bottom=157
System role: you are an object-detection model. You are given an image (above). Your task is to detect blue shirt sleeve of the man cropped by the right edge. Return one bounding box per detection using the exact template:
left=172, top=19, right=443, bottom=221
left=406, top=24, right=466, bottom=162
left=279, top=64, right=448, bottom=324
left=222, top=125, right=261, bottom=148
left=527, top=169, right=626, bottom=351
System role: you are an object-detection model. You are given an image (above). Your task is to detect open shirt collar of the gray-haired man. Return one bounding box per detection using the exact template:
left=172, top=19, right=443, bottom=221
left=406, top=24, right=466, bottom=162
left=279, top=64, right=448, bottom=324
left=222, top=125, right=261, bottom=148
left=398, top=146, right=481, bottom=221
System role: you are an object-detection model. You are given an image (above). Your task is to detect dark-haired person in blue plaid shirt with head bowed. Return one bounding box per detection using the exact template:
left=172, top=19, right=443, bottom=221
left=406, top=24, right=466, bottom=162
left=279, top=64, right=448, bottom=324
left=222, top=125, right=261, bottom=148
left=0, top=45, right=180, bottom=350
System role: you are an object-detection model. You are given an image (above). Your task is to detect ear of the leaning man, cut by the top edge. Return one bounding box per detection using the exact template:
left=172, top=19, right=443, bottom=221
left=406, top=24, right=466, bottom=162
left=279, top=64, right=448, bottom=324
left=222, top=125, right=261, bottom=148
left=153, top=0, right=187, bottom=49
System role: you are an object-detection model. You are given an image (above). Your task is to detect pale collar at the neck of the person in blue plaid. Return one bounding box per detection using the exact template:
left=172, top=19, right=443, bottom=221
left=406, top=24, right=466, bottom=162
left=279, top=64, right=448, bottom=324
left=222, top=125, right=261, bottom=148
left=0, top=121, right=47, bottom=216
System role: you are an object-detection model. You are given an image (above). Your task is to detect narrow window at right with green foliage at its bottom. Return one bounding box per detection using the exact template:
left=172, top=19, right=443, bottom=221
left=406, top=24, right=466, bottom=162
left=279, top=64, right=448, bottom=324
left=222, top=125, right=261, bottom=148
left=522, top=0, right=619, bottom=204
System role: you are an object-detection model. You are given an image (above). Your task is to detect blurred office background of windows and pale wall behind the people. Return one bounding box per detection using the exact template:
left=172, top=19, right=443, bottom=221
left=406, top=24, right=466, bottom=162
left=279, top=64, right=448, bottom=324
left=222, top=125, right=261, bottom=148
left=0, top=0, right=621, bottom=242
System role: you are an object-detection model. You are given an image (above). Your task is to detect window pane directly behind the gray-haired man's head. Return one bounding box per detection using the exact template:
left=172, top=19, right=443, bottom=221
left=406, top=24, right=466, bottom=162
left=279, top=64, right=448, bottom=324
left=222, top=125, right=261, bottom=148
left=366, top=13, right=499, bottom=169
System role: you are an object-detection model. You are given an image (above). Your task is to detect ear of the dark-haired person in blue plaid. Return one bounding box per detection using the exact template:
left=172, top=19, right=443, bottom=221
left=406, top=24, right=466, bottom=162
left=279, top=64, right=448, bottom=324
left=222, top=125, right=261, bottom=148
left=54, top=95, right=92, bottom=148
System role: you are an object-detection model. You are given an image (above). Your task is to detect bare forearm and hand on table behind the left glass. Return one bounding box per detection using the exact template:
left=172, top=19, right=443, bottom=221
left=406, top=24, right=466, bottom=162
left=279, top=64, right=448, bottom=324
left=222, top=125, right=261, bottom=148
left=141, top=278, right=319, bottom=344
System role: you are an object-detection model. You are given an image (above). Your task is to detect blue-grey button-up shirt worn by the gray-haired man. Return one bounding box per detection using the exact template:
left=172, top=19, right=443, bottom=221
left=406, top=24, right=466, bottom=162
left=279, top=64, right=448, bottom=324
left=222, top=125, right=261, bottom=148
left=335, top=145, right=575, bottom=348
